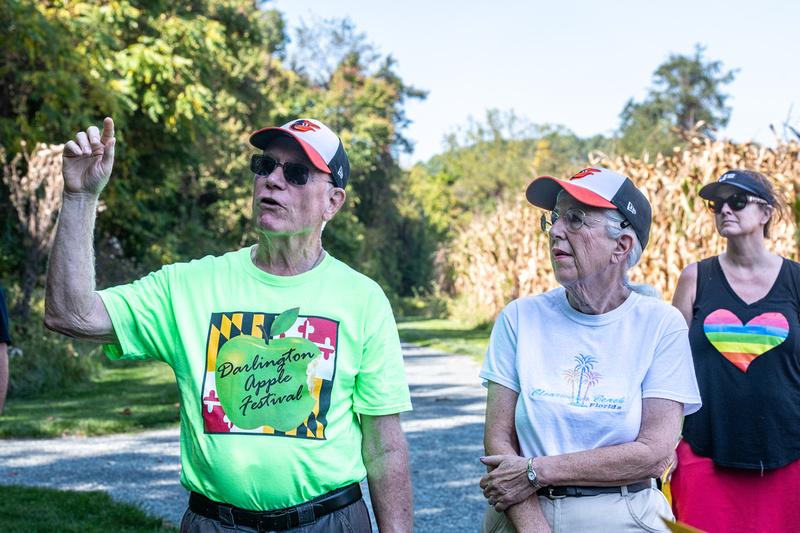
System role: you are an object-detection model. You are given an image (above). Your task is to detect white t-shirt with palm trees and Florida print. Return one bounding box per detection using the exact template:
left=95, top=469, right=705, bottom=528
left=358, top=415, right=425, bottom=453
left=480, top=288, right=701, bottom=457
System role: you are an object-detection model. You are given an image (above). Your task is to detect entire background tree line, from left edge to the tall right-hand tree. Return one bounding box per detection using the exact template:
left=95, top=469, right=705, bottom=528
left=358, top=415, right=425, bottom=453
left=0, top=0, right=735, bottom=336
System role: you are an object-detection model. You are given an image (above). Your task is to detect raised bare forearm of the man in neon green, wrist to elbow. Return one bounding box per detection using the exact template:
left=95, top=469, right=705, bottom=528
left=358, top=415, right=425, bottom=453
left=45, top=193, right=111, bottom=336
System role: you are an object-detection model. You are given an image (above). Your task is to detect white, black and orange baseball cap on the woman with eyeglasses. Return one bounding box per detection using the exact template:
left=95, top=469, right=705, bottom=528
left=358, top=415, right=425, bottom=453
left=525, top=167, right=653, bottom=249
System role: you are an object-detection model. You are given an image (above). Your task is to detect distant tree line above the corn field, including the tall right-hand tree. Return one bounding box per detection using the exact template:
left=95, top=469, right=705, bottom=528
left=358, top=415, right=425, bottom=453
left=409, top=45, right=736, bottom=258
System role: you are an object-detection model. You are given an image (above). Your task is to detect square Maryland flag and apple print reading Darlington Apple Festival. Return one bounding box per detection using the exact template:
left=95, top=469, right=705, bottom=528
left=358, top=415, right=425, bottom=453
left=202, top=308, right=339, bottom=439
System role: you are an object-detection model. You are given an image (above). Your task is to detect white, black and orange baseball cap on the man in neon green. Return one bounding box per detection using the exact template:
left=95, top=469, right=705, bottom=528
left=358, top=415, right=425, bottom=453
left=250, top=118, right=350, bottom=188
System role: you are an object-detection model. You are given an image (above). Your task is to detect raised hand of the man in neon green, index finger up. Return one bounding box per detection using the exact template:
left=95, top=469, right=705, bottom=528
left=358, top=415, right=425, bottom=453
left=62, top=117, right=115, bottom=196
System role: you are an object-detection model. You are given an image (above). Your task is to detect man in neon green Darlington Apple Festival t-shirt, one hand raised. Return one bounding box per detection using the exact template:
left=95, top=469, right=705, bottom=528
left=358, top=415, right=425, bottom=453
left=45, top=118, right=412, bottom=532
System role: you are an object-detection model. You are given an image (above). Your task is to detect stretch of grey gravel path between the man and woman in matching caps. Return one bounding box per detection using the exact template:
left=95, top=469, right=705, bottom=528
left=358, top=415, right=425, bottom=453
left=402, top=345, right=486, bottom=531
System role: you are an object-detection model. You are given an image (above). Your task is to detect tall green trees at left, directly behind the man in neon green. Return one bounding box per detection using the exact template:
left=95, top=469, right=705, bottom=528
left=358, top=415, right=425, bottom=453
left=0, top=0, right=428, bottom=304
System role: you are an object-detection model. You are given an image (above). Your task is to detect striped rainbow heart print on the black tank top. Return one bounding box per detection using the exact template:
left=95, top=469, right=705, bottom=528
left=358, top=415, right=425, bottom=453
left=703, top=309, right=789, bottom=372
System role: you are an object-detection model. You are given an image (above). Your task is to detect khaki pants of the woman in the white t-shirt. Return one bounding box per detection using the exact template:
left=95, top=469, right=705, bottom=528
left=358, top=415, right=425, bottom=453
left=482, top=487, right=675, bottom=533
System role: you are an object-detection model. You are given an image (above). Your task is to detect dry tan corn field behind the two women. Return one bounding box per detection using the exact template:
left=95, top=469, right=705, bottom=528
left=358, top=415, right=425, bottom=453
left=440, top=139, right=800, bottom=321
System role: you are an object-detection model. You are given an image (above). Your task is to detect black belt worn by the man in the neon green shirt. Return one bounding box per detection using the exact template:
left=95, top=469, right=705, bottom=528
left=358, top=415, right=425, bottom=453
left=189, top=483, right=361, bottom=531
